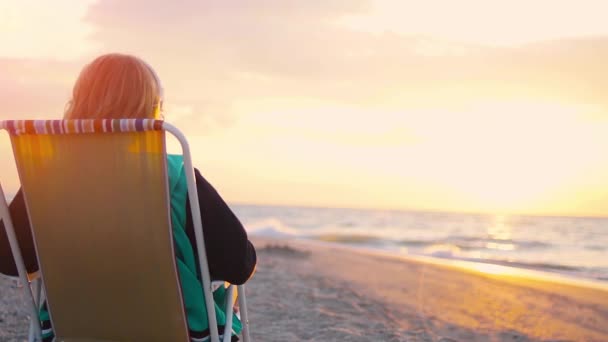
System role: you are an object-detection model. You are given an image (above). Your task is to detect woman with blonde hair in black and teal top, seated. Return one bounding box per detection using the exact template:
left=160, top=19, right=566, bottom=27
left=0, top=54, right=256, bottom=341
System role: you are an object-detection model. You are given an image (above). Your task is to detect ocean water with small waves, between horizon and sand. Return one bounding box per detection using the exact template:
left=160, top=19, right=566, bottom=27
left=231, top=205, right=608, bottom=283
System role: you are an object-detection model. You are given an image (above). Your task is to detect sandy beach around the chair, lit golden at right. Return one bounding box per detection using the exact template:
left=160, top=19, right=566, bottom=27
left=0, top=239, right=608, bottom=342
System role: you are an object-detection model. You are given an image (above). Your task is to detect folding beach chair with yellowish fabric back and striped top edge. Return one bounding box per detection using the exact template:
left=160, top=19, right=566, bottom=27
left=0, top=119, right=250, bottom=341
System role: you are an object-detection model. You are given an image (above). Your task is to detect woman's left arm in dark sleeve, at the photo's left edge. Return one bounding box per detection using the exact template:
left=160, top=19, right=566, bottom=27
left=0, top=189, right=38, bottom=276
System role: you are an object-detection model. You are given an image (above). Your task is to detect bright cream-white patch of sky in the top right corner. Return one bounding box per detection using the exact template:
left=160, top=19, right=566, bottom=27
left=343, top=0, right=608, bottom=46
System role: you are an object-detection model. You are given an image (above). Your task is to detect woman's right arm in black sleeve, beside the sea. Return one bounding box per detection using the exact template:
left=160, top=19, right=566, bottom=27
left=186, top=169, right=257, bottom=285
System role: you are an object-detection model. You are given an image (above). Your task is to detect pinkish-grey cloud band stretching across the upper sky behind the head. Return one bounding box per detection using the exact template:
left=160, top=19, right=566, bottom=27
left=0, top=0, right=608, bottom=124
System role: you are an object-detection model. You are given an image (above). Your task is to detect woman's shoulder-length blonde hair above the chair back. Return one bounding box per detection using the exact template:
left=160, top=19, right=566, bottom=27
left=64, top=53, right=163, bottom=119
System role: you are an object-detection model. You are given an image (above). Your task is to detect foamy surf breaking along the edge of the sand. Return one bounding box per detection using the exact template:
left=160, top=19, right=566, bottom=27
left=246, top=217, right=608, bottom=281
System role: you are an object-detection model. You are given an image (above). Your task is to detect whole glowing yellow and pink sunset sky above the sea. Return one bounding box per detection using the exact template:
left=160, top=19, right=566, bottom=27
left=0, top=0, right=608, bottom=216
